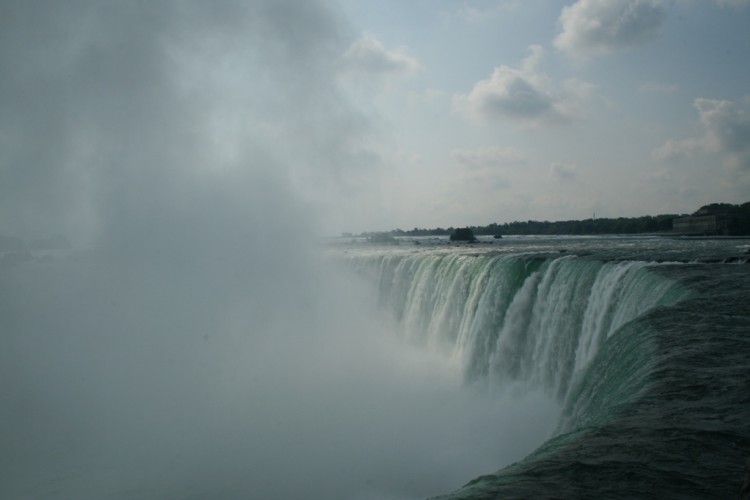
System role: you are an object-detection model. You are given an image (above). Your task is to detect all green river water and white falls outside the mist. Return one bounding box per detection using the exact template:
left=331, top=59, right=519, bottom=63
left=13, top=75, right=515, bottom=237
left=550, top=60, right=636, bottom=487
left=343, top=237, right=750, bottom=499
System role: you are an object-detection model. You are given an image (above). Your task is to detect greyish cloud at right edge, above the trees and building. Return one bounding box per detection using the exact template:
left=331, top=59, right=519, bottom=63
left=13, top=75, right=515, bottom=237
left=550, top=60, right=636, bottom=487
left=654, top=97, right=750, bottom=170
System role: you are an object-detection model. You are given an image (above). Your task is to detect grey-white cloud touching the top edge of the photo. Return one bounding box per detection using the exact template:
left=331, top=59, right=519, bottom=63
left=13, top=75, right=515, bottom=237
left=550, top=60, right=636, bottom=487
left=555, top=0, right=665, bottom=57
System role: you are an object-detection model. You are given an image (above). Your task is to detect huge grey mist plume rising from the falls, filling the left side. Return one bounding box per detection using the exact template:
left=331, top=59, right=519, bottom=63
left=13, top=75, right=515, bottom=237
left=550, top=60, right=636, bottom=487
left=0, top=0, right=554, bottom=499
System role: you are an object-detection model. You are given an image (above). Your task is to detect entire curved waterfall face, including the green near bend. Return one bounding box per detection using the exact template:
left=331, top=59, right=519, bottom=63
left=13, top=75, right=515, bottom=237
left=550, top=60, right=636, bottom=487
left=348, top=253, right=728, bottom=498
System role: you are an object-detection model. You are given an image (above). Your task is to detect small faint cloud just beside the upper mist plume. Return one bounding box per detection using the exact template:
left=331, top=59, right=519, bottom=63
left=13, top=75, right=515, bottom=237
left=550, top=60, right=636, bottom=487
left=340, top=33, right=423, bottom=76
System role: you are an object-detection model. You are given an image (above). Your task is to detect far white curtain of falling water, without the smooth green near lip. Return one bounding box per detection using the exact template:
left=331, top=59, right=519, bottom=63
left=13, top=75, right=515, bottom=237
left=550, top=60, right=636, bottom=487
left=349, top=252, right=685, bottom=402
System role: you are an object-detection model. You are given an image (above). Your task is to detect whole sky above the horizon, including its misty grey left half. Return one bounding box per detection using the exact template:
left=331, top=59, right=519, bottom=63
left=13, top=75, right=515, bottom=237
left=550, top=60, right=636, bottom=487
left=0, top=0, right=750, bottom=243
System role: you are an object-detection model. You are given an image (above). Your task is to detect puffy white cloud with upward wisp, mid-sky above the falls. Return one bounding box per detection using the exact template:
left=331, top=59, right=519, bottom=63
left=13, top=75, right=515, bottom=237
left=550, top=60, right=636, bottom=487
left=454, top=45, right=595, bottom=125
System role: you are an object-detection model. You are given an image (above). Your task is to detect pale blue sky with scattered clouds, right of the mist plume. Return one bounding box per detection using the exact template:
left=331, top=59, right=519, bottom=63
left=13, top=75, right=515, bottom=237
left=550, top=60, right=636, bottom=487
left=332, top=0, right=750, bottom=228
